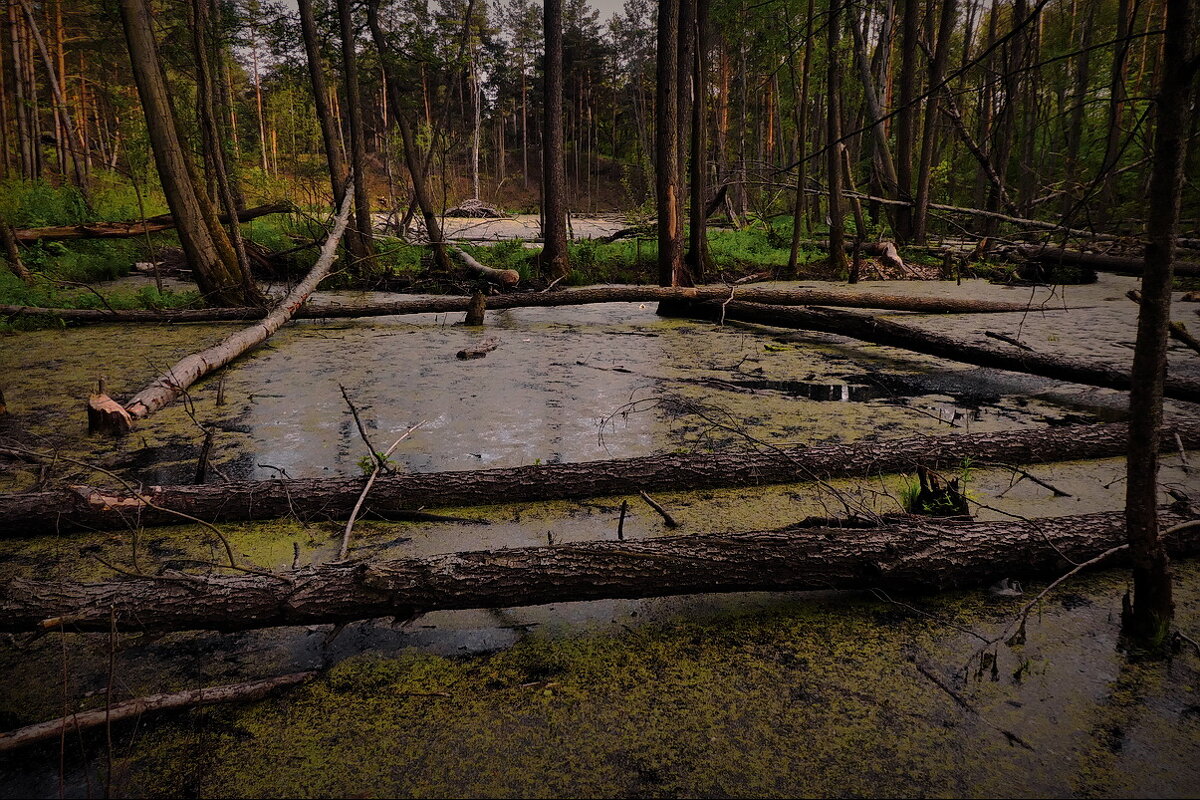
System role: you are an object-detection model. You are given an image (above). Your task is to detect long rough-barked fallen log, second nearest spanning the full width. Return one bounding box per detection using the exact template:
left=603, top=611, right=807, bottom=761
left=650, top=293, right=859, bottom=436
left=0, top=419, right=1200, bottom=536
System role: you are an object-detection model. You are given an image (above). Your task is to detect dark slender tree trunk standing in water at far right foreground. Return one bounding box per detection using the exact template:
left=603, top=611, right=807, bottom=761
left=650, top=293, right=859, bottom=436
left=1121, top=0, right=1196, bottom=648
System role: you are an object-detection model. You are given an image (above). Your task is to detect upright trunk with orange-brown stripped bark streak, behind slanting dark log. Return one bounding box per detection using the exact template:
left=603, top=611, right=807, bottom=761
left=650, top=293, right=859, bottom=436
left=654, top=0, right=683, bottom=287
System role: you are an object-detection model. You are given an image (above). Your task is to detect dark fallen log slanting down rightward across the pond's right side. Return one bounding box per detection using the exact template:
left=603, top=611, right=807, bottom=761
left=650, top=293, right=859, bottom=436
left=676, top=301, right=1200, bottom=403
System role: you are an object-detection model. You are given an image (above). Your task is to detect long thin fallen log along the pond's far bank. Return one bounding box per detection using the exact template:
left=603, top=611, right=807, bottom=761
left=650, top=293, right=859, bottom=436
left=0, top=285, right=1051, bottom=323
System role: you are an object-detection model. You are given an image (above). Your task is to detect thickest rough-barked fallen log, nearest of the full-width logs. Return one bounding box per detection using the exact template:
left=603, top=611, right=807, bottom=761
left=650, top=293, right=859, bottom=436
left=0, top=510, right=1200, bottom=632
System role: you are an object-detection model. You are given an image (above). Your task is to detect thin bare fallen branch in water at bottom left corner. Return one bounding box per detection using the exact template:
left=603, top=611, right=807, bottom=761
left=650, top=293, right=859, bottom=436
left=0, top=672, right=317, bottom=753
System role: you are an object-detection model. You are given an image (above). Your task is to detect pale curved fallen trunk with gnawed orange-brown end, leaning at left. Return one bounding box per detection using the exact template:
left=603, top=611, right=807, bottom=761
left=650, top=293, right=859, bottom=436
left=88, top=185, right=352, bottom=434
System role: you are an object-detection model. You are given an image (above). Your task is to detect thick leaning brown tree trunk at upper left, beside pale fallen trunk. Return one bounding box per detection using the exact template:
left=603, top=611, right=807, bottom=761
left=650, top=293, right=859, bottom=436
left=121, top=0, right=254, bottom=306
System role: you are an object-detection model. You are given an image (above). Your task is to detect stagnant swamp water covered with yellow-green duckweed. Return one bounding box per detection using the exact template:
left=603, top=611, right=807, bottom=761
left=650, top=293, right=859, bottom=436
left=0, top=277, right=1200, bottom=796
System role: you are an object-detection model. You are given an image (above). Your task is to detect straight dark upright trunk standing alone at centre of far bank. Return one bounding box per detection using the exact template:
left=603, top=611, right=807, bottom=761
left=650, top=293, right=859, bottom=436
left=541, top=0, right=570, bottom=278
